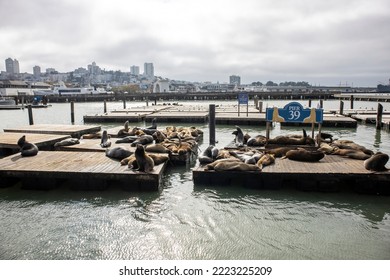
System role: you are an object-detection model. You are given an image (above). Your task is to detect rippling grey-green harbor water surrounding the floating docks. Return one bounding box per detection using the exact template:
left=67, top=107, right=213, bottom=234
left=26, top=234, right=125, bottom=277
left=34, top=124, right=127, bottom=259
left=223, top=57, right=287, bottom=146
left=0, top=100, right=390, bottom=260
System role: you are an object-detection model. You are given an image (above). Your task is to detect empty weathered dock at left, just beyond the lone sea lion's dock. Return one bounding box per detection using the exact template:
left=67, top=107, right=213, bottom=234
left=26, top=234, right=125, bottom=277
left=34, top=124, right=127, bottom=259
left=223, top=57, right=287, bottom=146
left=4, top=124, right=101, bottom=138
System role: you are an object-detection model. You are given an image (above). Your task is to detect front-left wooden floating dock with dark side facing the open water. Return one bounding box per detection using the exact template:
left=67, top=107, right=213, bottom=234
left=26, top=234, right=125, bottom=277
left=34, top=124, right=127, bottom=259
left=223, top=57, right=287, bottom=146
left=0, top=151, right=166, bottom=191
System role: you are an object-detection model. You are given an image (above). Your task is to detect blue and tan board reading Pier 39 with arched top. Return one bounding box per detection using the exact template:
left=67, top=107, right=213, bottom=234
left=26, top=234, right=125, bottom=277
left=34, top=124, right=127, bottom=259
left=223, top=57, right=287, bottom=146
left=266, top=102, right=324, bottom=123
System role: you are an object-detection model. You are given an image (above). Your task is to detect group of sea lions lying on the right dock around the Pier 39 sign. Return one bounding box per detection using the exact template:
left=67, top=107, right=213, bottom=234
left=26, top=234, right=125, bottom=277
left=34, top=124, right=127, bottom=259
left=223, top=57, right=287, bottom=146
left=198, top=126, right=389, bottom=171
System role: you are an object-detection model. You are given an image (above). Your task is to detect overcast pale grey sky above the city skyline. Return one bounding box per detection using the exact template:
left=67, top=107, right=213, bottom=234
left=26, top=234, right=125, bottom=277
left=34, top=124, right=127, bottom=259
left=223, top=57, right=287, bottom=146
left=0, top=0, right=390, bottom=86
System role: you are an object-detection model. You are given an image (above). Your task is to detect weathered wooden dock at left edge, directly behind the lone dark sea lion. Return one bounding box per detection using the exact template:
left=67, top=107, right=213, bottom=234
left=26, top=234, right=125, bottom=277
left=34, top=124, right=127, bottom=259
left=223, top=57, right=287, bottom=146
left=0, top=132, right=70, bottom=149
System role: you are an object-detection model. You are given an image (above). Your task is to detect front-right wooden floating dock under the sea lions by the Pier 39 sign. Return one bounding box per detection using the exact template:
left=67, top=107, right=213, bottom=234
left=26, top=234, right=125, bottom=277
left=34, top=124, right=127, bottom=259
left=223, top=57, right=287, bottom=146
left=193, top=155, right=390, bottom=195
